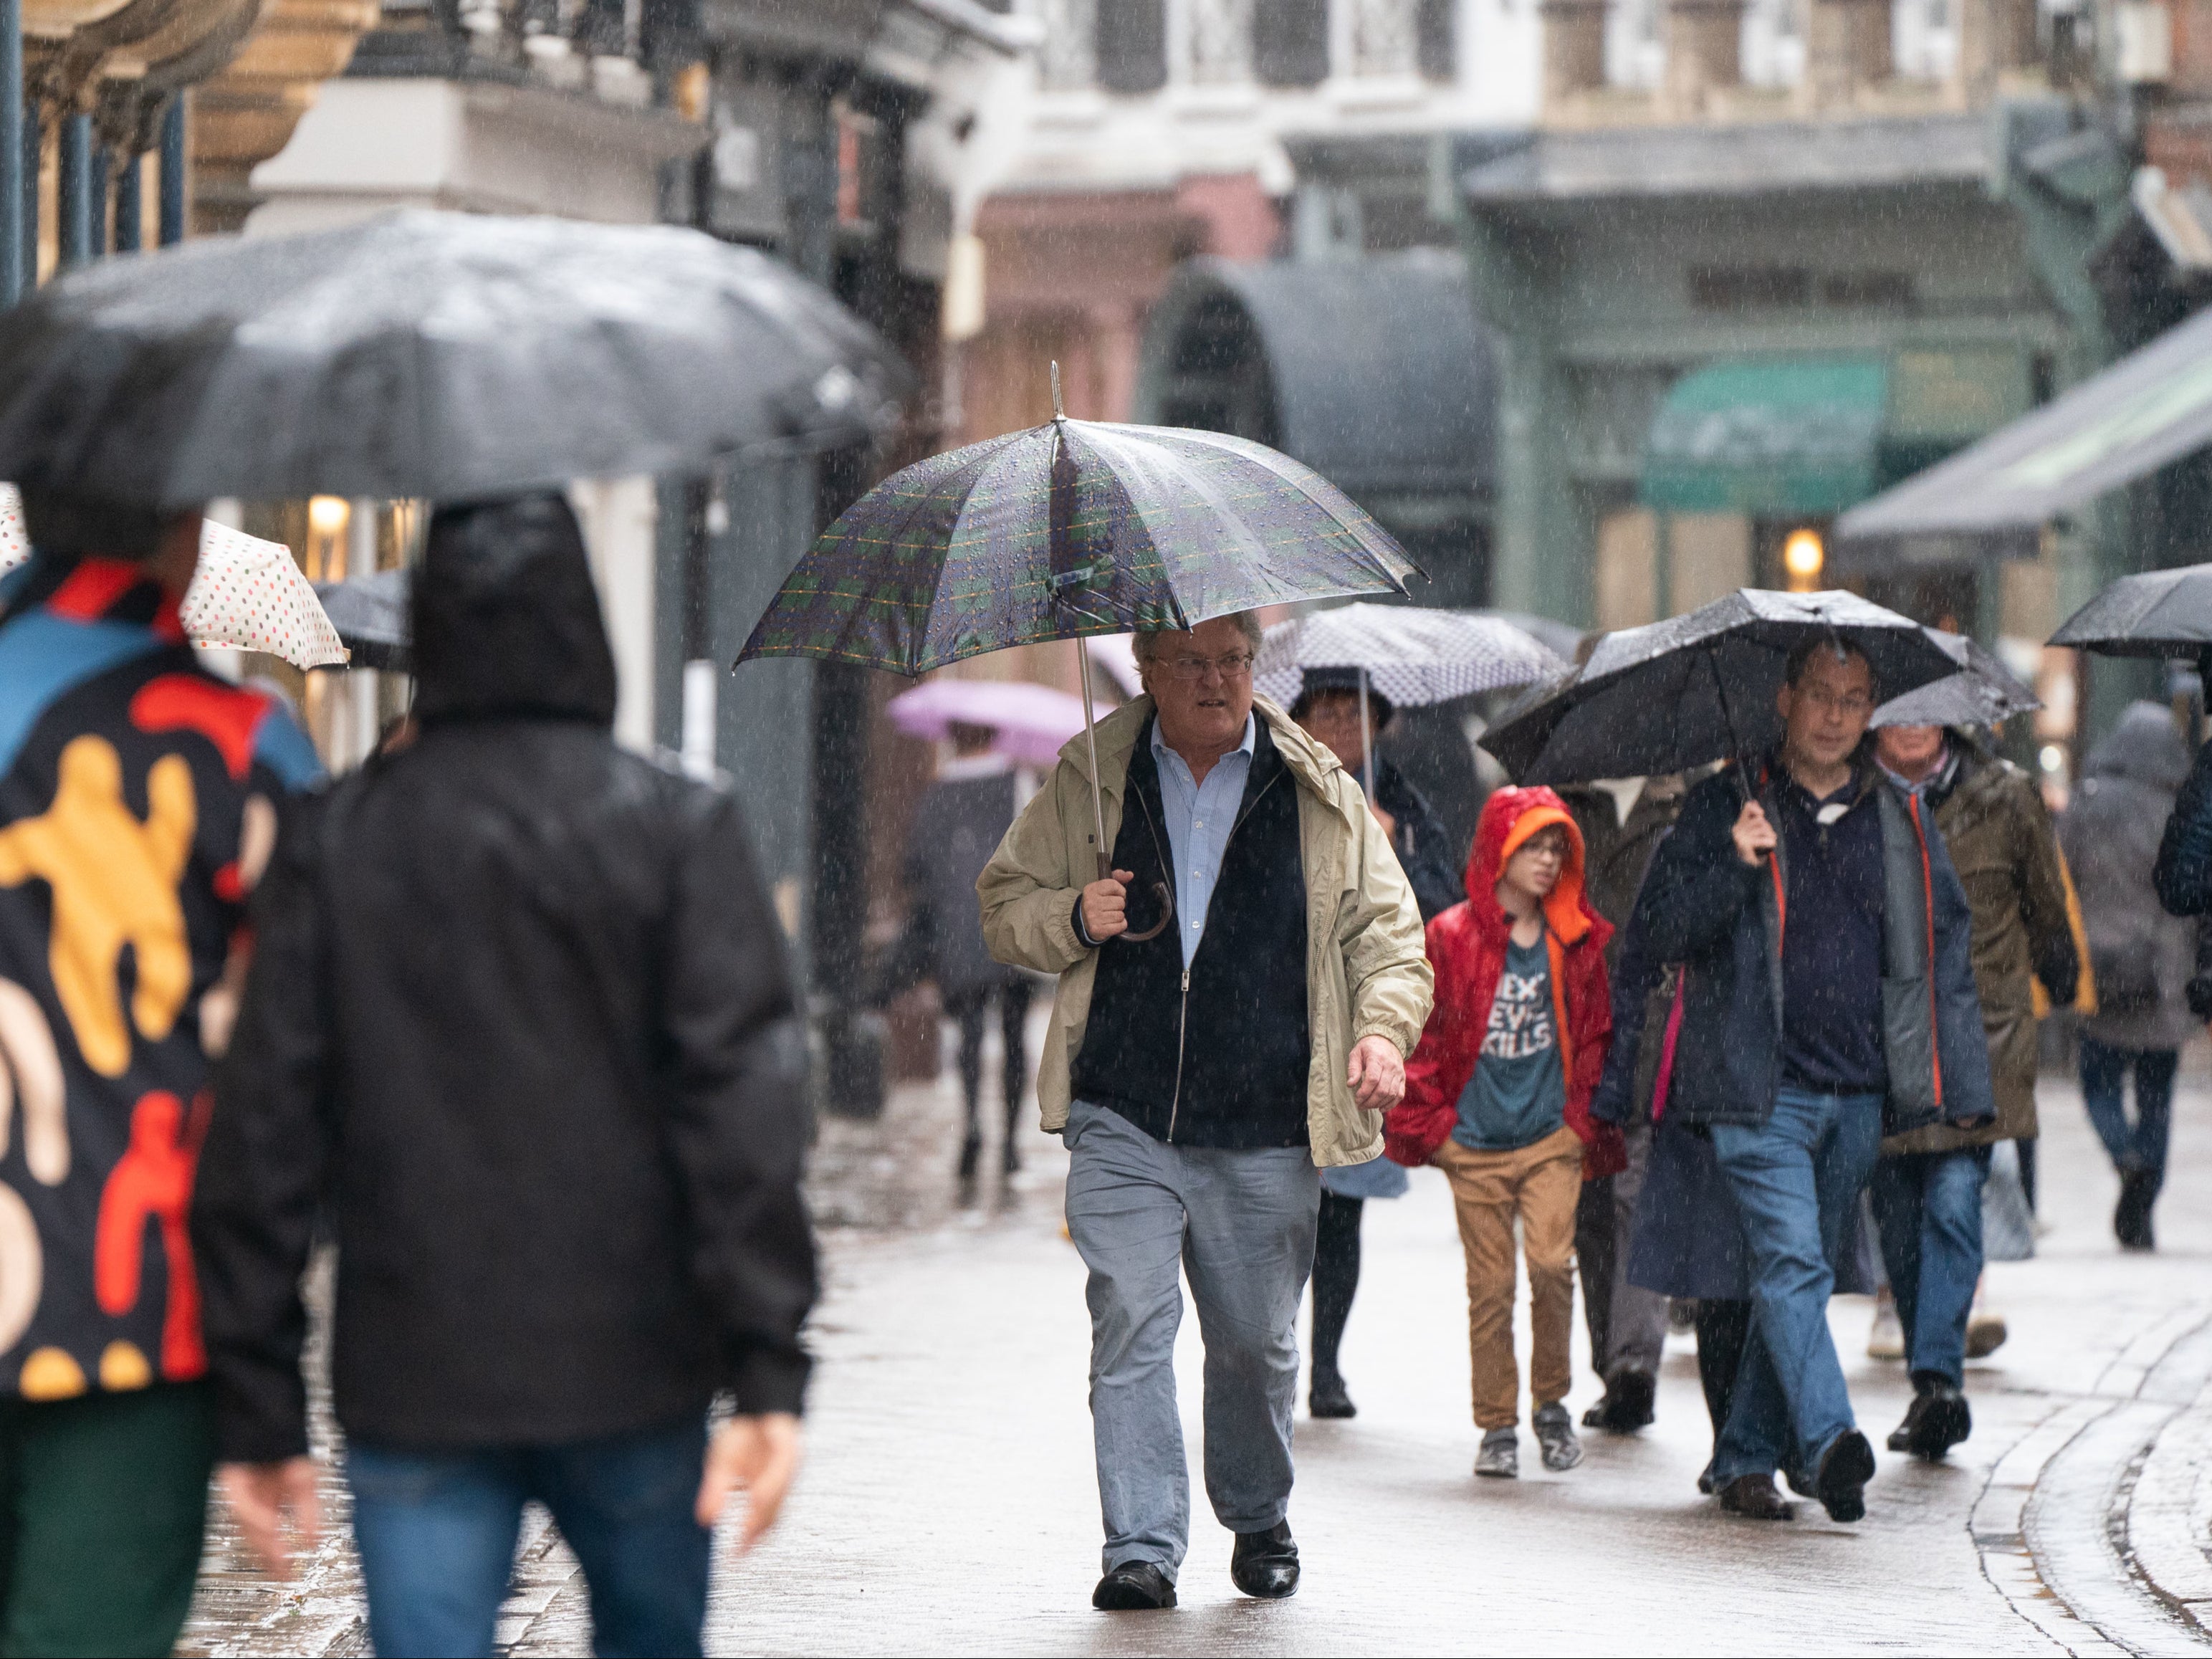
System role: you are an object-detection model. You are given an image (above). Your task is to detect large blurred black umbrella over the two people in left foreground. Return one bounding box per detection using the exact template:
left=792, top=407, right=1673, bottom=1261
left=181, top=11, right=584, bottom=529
left=0, top=210, right=909, bottom=507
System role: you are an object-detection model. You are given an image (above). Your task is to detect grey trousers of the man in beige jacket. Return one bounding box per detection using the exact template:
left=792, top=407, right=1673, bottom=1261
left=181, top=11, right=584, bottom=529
left=1064, top=1099, right=1321, bottom=1582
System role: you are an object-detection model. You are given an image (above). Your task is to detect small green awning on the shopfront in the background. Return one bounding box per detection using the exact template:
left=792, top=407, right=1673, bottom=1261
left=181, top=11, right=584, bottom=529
left=1639, top=356, right=1889, bottom=517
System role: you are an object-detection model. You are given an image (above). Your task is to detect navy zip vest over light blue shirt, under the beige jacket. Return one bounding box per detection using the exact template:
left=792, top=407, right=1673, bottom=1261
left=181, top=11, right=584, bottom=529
left=1075, top=721, right=1312, bottom=1148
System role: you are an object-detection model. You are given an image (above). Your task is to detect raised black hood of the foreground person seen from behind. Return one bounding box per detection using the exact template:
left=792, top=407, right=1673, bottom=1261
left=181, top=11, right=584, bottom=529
left=413, top=493, right=615, bottom=728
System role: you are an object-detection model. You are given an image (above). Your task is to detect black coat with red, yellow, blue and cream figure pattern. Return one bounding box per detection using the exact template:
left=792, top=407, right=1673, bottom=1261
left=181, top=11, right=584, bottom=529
left=0, top=558, right=319, bottom=1400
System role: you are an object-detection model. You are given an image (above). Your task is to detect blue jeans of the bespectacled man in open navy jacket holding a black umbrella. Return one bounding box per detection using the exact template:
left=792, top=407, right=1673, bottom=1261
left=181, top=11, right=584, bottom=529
left=1712, top=1089, right=1882, bottom=1486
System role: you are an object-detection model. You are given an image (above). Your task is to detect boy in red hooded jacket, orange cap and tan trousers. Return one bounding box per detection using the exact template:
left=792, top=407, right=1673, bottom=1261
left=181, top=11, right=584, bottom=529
left=1382, top=788, right=1626, bottom=1478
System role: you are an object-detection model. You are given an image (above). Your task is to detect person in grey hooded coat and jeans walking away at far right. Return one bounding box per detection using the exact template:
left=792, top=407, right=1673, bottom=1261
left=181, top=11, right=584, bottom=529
left=2059, top=701, right=2203, bottom=1250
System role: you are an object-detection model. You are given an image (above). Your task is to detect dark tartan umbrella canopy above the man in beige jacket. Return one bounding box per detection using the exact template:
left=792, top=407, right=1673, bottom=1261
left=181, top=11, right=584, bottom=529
left=739, top=420, right=1416, bottom=674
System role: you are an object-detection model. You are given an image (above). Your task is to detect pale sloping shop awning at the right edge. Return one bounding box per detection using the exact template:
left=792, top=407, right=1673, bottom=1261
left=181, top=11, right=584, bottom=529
left=1832, top=312, right=2212, bottom=568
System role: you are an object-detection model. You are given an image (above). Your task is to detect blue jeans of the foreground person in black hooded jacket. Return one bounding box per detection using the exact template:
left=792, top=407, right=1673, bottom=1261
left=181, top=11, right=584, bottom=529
left=345, top=1413, right=712, bottom=1657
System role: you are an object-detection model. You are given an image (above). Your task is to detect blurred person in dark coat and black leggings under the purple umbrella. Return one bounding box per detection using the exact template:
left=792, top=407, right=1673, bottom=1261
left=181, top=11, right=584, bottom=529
left=905, top=721, right=1031, bottom=1203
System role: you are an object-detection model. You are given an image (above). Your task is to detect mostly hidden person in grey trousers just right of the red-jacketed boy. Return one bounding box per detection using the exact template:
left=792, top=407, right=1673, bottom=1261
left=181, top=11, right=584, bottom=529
left=1559, top=776, right=1683, bottom=1433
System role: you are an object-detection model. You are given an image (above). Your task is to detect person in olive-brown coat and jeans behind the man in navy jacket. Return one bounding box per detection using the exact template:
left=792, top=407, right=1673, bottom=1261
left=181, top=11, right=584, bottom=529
left=1872, top=725, right=2079, bottom=1460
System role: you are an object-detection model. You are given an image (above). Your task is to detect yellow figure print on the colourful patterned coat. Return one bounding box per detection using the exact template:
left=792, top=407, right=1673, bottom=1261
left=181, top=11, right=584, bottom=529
left=0, top=737, right=197, bottom=1077
